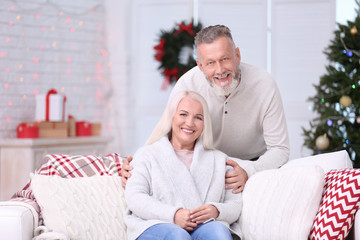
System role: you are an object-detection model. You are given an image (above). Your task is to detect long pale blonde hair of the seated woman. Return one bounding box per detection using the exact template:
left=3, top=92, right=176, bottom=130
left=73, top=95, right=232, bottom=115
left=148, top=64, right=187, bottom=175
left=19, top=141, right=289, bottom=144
left=145, top=91, right=214, bottom=149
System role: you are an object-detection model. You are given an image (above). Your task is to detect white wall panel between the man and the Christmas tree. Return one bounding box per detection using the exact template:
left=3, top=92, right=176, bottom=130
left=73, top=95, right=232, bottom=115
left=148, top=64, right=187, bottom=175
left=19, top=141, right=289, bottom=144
left=271, top=0, right=335, bottom=159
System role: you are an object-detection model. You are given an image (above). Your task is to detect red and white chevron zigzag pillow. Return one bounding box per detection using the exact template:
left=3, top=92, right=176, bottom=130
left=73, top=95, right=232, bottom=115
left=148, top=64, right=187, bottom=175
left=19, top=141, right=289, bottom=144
left=310, top=169, right=360, bottom=240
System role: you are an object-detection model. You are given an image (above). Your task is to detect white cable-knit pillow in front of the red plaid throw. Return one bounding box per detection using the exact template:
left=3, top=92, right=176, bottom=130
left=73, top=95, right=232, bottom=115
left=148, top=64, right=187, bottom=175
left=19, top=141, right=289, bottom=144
left=31, top=174, right=126, bottom=239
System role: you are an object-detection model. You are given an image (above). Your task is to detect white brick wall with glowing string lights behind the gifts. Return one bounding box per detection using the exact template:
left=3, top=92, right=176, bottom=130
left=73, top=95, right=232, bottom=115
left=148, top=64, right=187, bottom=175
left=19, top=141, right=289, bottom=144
left=0, top=0, right=111, bottom=138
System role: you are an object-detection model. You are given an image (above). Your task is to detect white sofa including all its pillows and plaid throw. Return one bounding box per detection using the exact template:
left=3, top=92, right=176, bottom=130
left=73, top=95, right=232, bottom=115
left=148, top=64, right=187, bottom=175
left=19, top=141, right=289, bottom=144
left=0, top=150, right=360, bottom=240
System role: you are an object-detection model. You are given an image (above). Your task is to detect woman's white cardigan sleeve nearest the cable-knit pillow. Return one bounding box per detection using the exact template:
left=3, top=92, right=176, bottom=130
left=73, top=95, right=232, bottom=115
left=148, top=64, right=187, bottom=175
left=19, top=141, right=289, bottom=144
left=125, top=150, right=181, bottom=223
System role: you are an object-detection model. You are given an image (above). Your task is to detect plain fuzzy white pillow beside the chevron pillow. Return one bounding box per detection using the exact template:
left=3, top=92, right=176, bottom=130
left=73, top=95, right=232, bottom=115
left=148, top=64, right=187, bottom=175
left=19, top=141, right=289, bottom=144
left=240, top=166, right=324, bottom=240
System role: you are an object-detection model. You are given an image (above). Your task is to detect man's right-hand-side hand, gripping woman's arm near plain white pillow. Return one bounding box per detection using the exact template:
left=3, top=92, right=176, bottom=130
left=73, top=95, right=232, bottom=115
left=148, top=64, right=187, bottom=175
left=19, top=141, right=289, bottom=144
left=225, top=160, right=248, bottom=193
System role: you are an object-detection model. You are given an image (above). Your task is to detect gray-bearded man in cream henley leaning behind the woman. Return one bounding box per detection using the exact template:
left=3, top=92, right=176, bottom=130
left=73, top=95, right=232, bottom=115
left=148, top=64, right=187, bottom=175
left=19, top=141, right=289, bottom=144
left=122, top=25, right=289, bottom=193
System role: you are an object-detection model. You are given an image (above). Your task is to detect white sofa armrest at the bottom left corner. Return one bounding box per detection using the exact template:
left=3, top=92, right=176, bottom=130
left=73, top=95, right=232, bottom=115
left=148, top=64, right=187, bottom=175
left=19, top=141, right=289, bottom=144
left=0, top=205, right=35, bottom=240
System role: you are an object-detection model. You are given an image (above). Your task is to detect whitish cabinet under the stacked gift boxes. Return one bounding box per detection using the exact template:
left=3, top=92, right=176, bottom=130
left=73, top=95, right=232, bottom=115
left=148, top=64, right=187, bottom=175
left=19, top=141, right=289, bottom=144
left=0, top=137, right=111, bottom=201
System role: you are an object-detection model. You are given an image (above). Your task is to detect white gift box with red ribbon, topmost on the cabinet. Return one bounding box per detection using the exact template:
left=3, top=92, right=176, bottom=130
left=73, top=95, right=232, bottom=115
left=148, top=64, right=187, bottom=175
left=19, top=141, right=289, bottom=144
left=35, top=89, right=67, bottom=122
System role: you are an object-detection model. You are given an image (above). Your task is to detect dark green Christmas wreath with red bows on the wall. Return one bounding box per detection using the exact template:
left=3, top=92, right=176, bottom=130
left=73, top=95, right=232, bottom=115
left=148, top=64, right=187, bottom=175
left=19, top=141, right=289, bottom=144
left=154, top=22, right=201, bottom=89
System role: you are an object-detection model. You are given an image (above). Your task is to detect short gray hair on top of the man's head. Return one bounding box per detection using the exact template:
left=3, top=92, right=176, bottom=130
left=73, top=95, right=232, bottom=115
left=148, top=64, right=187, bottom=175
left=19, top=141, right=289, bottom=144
left=195, top=25, right=235, bottom=49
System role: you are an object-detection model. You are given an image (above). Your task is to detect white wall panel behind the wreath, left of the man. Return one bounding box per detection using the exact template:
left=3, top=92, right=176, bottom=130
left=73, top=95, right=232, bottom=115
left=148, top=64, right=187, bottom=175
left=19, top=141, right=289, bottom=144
left=128, top=0, right=192, bottom=153
